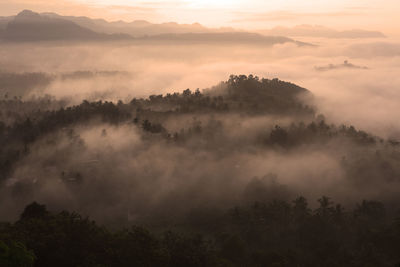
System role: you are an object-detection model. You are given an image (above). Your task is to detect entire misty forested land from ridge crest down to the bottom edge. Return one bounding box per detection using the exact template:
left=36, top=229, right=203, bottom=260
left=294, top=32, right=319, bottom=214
left=0, top=74, right=400, bottom=267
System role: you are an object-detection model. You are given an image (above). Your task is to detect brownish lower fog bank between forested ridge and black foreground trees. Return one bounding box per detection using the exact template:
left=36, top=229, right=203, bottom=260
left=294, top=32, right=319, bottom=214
left=0, top=110, right=399, bottom=225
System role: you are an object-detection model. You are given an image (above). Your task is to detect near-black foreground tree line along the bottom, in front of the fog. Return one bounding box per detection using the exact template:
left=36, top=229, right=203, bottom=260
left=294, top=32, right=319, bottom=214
left=0, top=196, right=400, bottom=267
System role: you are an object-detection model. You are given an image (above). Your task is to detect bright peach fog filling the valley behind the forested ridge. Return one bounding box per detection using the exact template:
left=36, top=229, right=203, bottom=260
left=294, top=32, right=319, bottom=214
left=0, top=38, right=400, bottom=138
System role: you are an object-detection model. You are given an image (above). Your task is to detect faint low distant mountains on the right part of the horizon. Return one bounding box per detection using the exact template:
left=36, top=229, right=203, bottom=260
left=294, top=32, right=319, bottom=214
left=260, top=25, right=386, bottom=39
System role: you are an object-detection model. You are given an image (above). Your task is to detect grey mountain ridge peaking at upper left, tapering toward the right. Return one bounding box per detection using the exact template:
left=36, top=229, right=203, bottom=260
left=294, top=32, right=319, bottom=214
left=0, top=10, right=308, bottom=45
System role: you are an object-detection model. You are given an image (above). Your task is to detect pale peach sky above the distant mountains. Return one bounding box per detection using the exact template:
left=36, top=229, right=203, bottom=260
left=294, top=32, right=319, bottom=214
left=0, top=0, right=400, bottom=34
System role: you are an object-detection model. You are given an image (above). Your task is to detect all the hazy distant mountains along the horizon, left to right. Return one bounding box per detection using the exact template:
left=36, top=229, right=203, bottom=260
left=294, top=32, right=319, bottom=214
left=0, top=10, right=384, bottom=45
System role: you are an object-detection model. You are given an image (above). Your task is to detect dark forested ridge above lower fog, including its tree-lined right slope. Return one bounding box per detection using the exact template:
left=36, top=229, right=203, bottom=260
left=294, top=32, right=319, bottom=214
left=0, top=75, right=390, bottom=184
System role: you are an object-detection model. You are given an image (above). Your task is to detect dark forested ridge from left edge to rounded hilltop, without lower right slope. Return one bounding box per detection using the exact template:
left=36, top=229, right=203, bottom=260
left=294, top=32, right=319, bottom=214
left=0, top=75, right=315, bottom=180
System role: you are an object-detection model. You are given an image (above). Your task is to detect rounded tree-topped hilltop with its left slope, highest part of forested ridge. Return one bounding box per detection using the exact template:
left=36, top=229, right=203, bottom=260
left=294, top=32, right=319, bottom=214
left=131, top=75, right=315, bottom=116
